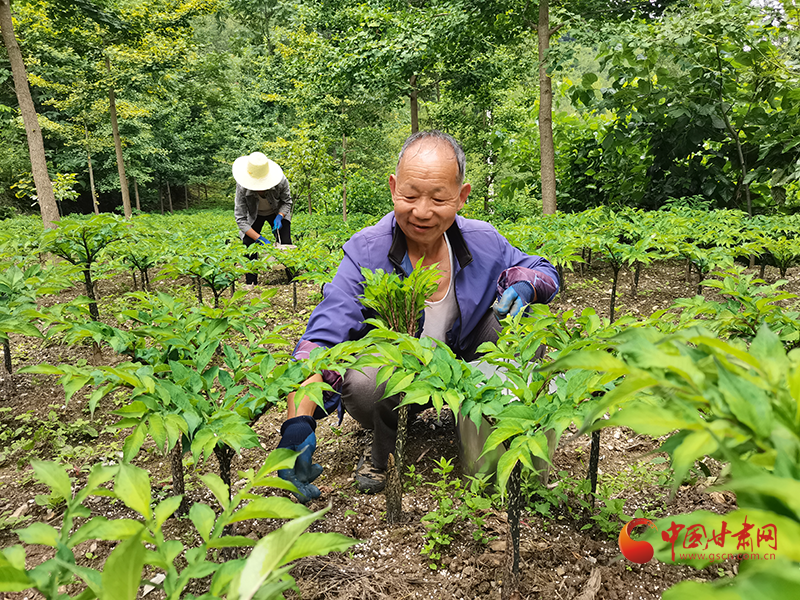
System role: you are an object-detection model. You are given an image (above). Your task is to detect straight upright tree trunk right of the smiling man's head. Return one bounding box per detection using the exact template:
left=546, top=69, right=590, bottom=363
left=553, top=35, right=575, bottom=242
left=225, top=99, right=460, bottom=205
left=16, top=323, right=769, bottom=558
left=537, top=0, right=557, bottom=215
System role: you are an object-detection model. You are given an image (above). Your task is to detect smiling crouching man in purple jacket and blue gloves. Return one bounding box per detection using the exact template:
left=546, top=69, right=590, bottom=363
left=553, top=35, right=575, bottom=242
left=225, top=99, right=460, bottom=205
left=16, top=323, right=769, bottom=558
left=278, top=131, right=558, bottom=501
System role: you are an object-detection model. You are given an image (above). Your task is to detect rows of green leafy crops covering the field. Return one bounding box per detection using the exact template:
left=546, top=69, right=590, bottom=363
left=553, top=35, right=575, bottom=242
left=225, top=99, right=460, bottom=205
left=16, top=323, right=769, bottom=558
left=0, top=210, right=800, bottom=598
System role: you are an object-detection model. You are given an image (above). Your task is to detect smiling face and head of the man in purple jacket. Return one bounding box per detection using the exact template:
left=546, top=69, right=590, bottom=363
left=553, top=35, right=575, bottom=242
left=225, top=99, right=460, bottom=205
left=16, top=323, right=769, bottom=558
left=389, top=138, right=470, bottom=250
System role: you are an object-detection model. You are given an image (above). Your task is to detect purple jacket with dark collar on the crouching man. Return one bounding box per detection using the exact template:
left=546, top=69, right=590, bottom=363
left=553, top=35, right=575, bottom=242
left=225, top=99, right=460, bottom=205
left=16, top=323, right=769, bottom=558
left=294, top=212, right=558, bottom=413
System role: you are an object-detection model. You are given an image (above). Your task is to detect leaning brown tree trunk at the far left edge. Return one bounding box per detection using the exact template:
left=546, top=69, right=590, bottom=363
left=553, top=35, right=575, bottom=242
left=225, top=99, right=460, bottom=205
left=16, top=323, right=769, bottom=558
left=0, top=0, right=58, bottom=229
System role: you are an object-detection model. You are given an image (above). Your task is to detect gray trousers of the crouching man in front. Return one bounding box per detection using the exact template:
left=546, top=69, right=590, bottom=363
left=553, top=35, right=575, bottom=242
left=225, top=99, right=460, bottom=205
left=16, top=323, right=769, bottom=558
left=342, top=309, right=502, bottom=469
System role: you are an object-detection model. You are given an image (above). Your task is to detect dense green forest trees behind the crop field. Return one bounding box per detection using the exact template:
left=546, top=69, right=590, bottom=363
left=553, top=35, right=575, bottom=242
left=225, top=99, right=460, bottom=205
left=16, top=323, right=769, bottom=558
left=0, top=0, right=800, bottom=219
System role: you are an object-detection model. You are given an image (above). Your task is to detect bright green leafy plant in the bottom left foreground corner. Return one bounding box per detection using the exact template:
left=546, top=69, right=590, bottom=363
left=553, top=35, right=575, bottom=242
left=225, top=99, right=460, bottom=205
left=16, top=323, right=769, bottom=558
left=0, top=450, right=355, bottom=600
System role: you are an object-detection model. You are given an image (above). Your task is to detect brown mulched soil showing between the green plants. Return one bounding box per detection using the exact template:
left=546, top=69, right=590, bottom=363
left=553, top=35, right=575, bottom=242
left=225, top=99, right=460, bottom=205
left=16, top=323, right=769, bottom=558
left=0, top=255, right=800, bottom=600
